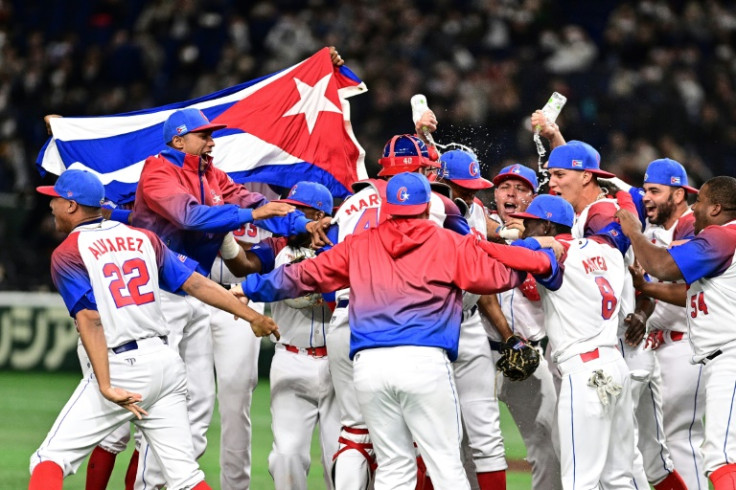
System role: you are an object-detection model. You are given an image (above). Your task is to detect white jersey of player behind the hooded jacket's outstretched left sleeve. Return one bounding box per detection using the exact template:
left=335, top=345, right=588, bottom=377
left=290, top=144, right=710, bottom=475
left=264, top=243, right=332, bottom=347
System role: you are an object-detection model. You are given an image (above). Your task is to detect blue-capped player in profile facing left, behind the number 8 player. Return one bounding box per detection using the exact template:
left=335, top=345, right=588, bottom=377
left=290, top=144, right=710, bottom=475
left=547, top=136, right=683, bottom=490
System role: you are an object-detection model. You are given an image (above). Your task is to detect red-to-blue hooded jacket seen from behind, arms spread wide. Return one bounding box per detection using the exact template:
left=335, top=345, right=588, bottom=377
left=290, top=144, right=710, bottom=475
left=242, top=219, right=550, bottom=360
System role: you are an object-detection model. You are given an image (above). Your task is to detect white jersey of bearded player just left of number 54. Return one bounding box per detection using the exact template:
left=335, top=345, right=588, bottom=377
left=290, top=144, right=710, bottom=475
left=644, top=209, right=695, bottom=332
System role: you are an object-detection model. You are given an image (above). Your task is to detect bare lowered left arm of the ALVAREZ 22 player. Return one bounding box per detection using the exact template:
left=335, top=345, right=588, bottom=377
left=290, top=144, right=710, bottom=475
left=75, top=309, right=148, bottom=419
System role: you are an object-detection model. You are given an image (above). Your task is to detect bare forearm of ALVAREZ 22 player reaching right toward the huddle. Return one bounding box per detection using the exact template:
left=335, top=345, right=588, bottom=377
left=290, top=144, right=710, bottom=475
left=181, top=272, right=281, bottom=339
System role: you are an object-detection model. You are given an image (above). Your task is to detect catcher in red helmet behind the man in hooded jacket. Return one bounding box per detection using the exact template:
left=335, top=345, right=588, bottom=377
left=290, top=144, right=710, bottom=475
left=326, top=128, right=470, bottom=490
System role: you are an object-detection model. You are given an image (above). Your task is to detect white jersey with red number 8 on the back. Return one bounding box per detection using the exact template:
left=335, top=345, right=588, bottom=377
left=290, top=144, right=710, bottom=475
left=539, top=235, right=628, bottom=363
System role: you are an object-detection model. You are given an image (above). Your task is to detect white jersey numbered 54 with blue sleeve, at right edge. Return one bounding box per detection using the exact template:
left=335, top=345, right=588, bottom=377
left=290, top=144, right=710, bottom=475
left=669, top=220, right=736, bottom=362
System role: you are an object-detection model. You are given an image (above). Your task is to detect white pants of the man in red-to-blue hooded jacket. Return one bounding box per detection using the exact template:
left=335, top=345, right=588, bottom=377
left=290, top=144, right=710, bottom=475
left=353, top=346, right=470, bottom=490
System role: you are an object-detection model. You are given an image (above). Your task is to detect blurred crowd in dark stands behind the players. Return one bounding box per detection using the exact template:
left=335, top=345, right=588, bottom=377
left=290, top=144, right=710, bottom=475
left=0, top=0, right=736, bottom=290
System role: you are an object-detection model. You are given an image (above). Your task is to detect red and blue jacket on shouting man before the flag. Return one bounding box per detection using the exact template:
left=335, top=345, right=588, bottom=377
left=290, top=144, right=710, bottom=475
left=132, top=148, right=309, bottom=275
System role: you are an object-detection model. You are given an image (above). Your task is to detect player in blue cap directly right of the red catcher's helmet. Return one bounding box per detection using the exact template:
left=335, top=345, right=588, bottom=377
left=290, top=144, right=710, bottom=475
left=438, top=150, right=508, bottom=490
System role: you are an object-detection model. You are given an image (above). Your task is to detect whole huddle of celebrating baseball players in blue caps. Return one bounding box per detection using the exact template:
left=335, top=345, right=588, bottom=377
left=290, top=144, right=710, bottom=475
left=30, top=58, right=736, bottom=490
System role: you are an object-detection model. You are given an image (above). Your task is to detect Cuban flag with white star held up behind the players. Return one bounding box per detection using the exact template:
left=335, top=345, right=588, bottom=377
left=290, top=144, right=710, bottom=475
left=36, top=48, right=368, bottom=203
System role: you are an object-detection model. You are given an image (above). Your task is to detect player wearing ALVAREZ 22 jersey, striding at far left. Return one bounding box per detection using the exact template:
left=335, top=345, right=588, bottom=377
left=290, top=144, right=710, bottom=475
left=29, top=170, right=278, bottom=490
